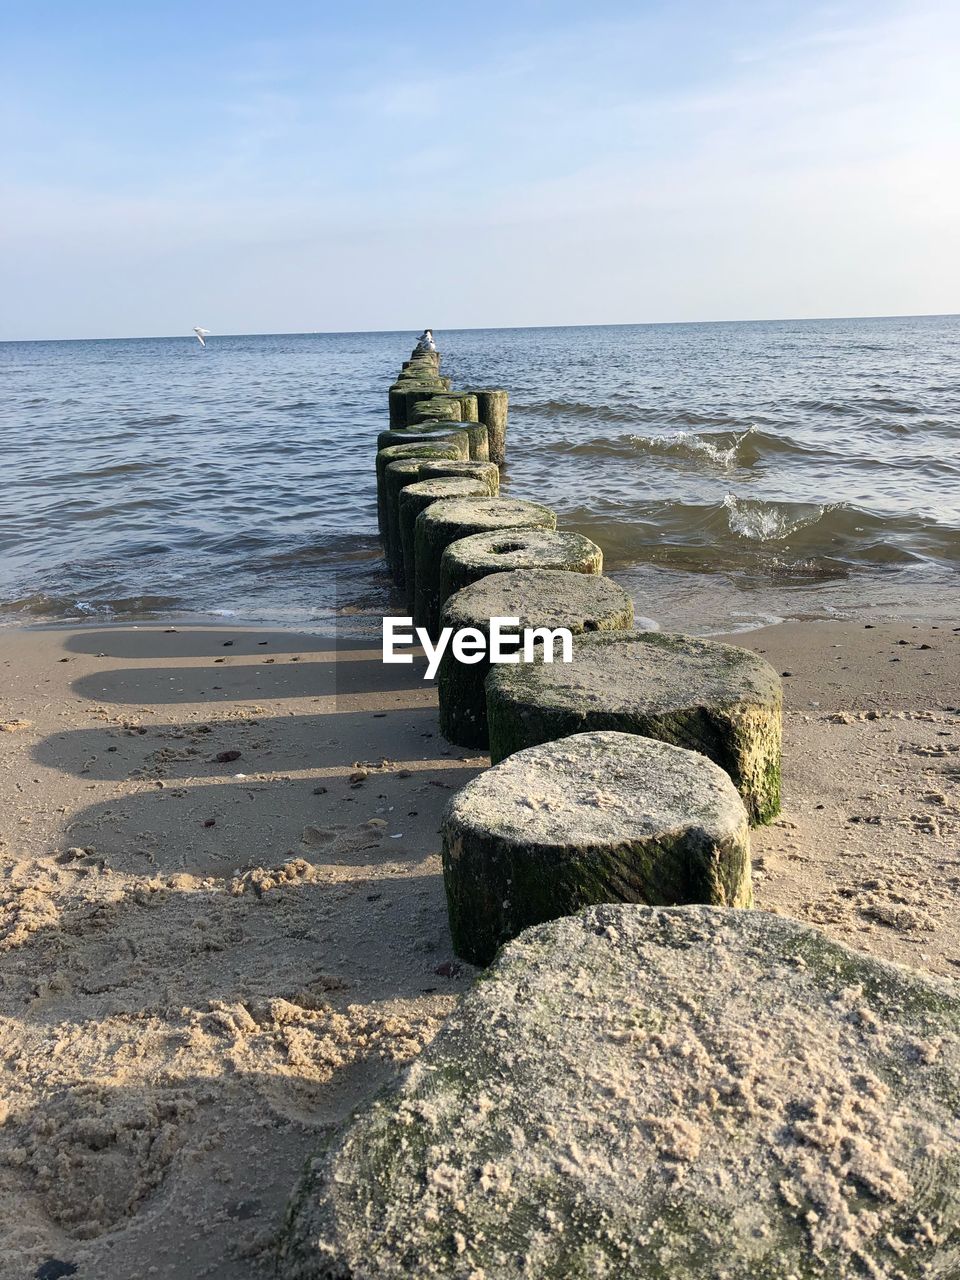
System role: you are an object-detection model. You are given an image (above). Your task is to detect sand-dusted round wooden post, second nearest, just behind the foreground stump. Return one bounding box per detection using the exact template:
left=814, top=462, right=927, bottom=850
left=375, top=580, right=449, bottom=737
left=440, top=732, right=753, bottom=965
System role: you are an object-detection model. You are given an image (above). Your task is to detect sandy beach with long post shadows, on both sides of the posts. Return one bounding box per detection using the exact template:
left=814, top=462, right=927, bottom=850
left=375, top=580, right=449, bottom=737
left=0, top=622, right=960, bottom=1280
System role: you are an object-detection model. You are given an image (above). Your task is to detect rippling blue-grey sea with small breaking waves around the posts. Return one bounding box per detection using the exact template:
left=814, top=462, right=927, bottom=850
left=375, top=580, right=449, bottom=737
left=0, top=316, right=960, bottom=630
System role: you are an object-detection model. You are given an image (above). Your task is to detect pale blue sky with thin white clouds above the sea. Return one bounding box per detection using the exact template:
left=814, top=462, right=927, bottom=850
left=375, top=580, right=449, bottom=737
left=0, top=0, right=960, bottom=339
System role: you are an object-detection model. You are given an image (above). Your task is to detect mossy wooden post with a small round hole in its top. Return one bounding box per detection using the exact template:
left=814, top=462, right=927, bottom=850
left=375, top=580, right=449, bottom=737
left=440, top=529, right=603, bottom=607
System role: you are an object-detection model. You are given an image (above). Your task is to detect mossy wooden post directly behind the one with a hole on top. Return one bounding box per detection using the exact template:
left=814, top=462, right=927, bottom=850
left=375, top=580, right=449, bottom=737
left=413, top=498, right=557, bottom=636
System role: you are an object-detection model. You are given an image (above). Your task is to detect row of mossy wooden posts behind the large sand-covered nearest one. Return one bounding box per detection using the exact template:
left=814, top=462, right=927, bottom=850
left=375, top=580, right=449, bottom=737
left=376, top=335, right=781, bottom=964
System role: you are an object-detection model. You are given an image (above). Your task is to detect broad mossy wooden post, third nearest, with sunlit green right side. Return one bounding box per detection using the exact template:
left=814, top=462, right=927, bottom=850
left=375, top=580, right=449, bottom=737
left=486, top=631, right=782, bottom=823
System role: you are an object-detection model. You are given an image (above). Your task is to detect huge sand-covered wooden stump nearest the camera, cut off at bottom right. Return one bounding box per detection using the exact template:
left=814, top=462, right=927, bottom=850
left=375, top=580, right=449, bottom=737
left=280, top=905, right=960, bottom=1280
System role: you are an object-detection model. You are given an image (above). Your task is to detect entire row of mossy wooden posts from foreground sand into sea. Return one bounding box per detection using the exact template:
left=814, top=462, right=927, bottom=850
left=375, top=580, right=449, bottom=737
left=273, top=353, right=936, bottom=1280
